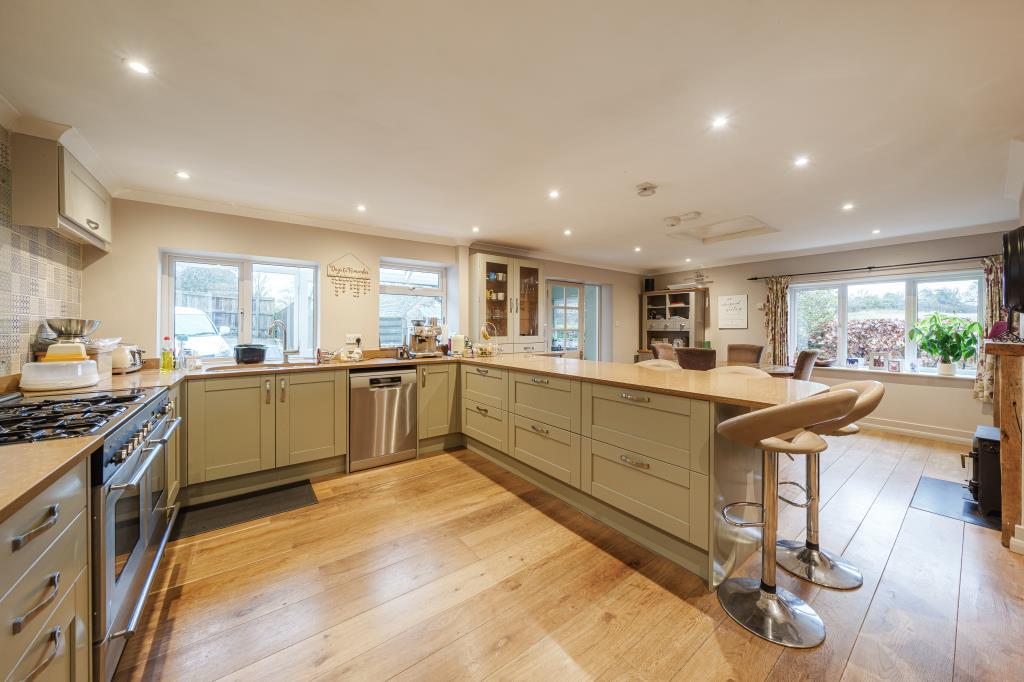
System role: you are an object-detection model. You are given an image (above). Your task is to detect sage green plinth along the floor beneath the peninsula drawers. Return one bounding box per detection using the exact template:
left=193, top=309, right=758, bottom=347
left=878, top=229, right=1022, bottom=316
left=466, top=436, right=712, bottom=589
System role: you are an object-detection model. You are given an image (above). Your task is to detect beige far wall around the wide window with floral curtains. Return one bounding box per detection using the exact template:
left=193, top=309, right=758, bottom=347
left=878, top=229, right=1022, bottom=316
left=655, top=231, right=1002, bottom=441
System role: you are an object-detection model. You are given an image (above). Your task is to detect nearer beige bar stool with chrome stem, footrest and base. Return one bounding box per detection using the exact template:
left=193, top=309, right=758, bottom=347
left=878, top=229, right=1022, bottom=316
left=718, top=390, right=857, bottom=648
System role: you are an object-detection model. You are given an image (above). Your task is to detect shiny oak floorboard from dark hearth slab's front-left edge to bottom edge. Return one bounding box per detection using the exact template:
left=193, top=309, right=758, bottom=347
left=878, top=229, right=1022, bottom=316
left=843, top=508, right=964, bottom=680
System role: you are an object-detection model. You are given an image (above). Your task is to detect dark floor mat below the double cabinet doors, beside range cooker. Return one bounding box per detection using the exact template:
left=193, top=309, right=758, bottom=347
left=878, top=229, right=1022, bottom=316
left=171, top=480, right=317, bottom=541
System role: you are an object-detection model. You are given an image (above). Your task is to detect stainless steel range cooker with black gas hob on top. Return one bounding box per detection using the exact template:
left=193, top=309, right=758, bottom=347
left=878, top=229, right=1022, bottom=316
left=0, top=388, right=181, bottom=681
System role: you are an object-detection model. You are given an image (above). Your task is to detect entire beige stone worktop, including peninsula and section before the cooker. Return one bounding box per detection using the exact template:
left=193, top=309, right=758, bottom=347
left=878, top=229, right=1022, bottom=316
left=0, top=354, right=828, bottom=521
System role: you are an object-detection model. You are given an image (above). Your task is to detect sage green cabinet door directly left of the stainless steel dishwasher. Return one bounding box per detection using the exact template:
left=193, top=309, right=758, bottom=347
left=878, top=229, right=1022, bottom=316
left=274, top=371, right=348, bottom=467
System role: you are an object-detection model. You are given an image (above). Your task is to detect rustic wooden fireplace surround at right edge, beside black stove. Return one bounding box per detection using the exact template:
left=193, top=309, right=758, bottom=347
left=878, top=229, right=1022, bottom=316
left=985, top=341, right=1024, bottom=547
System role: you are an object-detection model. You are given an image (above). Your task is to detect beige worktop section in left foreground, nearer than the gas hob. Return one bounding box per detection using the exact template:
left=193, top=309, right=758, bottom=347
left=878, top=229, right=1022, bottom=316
left=0, top=436, right=102, bottom=523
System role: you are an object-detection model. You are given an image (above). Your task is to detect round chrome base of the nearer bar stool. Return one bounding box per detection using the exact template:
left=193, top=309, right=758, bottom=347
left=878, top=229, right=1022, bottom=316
left=718, top=578, right=825, bottom=649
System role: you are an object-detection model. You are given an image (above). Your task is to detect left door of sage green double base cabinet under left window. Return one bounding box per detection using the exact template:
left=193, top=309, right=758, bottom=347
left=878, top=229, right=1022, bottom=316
left=185, top=375, right=276, bottom=485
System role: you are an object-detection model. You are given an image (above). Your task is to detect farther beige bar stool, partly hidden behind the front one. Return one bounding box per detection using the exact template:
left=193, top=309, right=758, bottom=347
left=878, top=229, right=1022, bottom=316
left=777, top=381, right=886, bottom=590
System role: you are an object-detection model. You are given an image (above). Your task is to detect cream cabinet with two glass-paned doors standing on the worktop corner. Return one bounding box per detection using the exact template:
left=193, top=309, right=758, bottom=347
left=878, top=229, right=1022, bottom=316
left=469, top=253, right=547, bottom=349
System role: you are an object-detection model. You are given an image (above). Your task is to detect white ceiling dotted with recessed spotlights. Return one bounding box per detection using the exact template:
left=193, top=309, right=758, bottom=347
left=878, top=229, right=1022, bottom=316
left=0, top=0, right=1024, bottom=271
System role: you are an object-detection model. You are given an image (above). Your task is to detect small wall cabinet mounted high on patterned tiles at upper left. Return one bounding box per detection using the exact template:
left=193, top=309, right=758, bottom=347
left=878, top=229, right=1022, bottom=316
left=11, top=133, right=113, bottom=246
